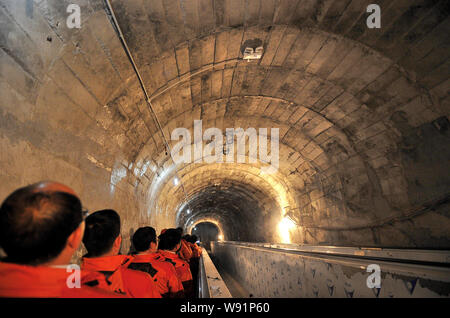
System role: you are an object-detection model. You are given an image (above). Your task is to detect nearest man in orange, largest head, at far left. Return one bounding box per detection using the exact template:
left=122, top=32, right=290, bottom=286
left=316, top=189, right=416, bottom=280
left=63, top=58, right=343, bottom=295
left=0, top=181, right=119, bottom=298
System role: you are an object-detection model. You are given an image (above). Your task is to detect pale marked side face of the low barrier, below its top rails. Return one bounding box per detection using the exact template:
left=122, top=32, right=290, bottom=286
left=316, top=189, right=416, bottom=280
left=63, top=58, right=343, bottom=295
left=211, top=242, right=450, bottom=298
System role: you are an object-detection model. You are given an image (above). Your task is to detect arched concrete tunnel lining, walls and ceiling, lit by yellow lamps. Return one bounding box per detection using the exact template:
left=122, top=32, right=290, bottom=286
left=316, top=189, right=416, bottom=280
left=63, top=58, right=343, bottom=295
left=0, top=0, right=450, bottom=300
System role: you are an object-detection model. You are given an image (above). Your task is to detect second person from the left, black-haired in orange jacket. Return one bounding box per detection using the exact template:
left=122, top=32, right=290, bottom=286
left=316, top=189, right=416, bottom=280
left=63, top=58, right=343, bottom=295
left=81, top=210, right=161, bottom=298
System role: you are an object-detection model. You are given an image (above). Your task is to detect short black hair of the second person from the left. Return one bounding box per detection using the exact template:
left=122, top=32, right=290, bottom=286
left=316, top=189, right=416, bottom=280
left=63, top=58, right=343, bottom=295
left=83, top=210, right=120, bottom=257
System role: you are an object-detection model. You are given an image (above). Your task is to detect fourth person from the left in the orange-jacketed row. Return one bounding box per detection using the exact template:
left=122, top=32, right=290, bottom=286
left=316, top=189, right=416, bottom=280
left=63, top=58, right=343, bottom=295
left=156, top=229, right=194, bottom=298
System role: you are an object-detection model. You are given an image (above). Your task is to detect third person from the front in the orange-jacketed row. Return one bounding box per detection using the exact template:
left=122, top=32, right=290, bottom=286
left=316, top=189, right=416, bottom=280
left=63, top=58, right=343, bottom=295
left=128, top=226, right=184, bottom=298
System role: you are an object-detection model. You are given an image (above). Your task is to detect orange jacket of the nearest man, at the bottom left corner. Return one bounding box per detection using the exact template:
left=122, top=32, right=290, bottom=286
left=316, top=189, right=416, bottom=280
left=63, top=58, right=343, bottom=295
left=0, top=262, right=123, bottom=298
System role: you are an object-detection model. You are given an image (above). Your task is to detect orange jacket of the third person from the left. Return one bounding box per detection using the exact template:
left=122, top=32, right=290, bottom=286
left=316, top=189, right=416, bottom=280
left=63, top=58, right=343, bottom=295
left=128, top=253, right=184, bottom=298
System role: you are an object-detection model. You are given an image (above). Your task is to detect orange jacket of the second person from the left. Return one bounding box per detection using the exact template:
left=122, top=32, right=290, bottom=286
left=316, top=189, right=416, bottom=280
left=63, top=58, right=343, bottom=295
left=81, top=255, right=161, bottom=298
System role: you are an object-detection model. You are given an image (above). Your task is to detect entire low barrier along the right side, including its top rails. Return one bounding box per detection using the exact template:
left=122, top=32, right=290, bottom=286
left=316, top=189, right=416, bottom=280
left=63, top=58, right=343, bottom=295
left=211, top=241, right=450, bottom=297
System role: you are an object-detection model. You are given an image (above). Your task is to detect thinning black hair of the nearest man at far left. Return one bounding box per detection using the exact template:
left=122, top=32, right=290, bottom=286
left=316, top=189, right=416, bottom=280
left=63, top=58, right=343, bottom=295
left=0, top=183, right=83, bottom=265
